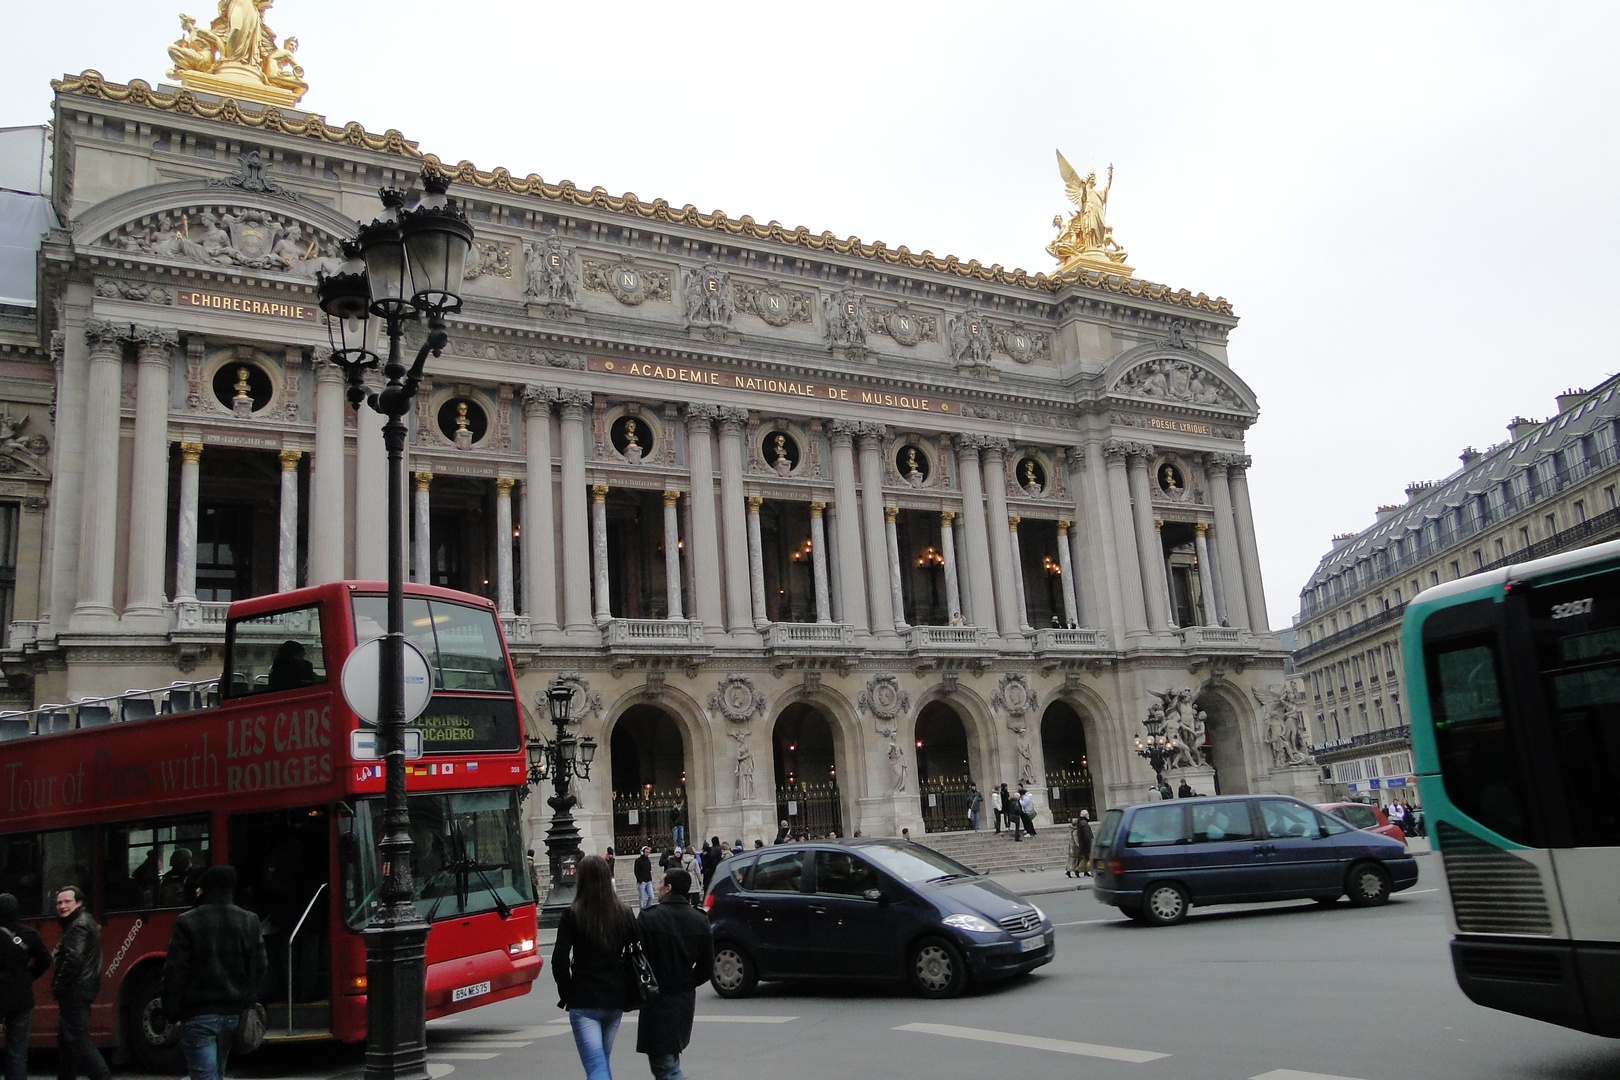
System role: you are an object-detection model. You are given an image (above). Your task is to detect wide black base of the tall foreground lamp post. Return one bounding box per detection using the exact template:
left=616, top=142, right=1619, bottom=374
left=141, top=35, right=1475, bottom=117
left=363, top=921, right=429, bottom=1080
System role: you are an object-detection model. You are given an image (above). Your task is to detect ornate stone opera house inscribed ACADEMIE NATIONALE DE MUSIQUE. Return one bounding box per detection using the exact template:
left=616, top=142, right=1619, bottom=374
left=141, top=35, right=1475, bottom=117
left=0, top=19, right=1296, bottom=847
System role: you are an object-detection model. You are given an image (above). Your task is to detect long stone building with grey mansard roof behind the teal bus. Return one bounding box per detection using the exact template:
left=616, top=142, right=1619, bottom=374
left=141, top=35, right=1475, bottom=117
left=1294, top=379, right=1620, bottom=801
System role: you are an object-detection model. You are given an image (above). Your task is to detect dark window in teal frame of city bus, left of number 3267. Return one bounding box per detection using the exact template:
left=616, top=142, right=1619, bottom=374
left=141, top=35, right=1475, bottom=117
left=1424, top=638, right=1531, bottom=844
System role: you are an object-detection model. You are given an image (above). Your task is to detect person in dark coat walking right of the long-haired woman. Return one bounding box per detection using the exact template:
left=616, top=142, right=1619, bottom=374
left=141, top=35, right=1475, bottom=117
left=635, top=870, right=714, bottom=1080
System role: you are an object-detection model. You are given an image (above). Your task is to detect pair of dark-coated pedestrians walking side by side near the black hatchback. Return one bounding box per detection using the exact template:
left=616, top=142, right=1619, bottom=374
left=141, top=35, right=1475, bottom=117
left=551, top=840, right=718, bottom=1080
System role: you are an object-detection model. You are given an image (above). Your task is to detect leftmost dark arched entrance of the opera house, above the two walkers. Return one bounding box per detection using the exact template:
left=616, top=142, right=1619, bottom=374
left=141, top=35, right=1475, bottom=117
left=608, top=704, right=693, bottom=852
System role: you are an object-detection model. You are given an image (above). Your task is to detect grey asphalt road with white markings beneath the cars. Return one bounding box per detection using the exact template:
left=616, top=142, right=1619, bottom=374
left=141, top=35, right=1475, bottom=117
left=32, top=858, right=1620, bottom=1080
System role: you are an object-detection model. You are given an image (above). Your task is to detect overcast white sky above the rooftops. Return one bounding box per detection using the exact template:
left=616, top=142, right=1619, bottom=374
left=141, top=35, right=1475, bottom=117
left=0, top=0, right=1620, bottom=627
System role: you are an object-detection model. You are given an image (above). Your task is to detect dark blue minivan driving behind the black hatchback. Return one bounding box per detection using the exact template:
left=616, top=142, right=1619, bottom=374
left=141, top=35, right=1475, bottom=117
left=1092, top=795, right=1418, bottom=926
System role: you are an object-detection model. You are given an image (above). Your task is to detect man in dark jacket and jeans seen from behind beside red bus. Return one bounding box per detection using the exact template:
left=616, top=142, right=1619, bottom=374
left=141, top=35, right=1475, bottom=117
left=164, top=866, right=266, bottom=1080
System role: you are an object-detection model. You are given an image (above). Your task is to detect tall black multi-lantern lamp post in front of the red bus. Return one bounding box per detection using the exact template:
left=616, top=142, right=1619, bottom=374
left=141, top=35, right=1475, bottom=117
left=319, top=172, right=473, bottom=1080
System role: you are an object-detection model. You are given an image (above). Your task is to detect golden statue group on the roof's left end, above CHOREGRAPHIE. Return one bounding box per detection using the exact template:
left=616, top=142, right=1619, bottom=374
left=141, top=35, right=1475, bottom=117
left=168, top=0, right=309, bottom=105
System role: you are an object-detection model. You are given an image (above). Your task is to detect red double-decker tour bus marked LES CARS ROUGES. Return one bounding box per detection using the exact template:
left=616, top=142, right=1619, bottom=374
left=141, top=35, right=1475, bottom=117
left=0, top=581, right=541, bottom=1069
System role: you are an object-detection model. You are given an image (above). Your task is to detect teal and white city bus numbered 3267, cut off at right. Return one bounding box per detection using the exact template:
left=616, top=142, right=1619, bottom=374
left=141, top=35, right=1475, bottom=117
left=1401, top=541, right=1620, bottom=1036
